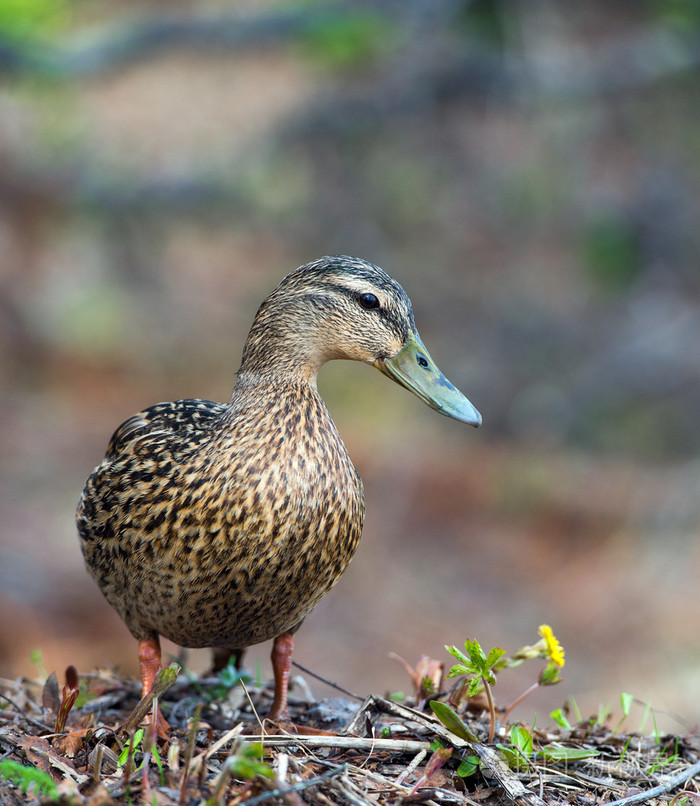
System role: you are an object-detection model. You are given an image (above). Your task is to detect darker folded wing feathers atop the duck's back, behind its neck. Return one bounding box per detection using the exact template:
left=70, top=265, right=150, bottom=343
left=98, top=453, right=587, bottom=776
left=105, top=399, right=227, bottom=460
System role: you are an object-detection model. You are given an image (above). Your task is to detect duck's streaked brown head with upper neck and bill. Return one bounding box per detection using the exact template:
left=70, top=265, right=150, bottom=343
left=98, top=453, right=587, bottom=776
left=239, top=255, right=481, bottom=426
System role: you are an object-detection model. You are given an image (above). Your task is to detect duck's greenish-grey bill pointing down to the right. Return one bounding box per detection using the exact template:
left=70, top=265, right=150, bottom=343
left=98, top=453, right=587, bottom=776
left=376, top=333, right=481, bottom=428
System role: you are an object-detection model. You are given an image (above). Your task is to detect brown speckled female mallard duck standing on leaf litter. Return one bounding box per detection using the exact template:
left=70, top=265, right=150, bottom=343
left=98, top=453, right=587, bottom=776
left=77, top=256, right=481, bottom=719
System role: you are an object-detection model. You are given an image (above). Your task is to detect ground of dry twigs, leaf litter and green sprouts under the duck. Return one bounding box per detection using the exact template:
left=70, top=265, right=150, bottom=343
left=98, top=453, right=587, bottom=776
left=0, top=664, right=700, bottom=806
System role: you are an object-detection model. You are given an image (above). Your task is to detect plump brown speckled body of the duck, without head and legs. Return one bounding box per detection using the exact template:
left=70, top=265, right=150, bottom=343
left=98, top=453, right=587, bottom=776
left=78, top=385, right=364, bottom=647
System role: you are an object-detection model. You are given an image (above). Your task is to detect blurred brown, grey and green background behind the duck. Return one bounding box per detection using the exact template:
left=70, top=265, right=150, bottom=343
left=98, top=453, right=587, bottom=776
left=0, top=0, right=700, bottom=731
